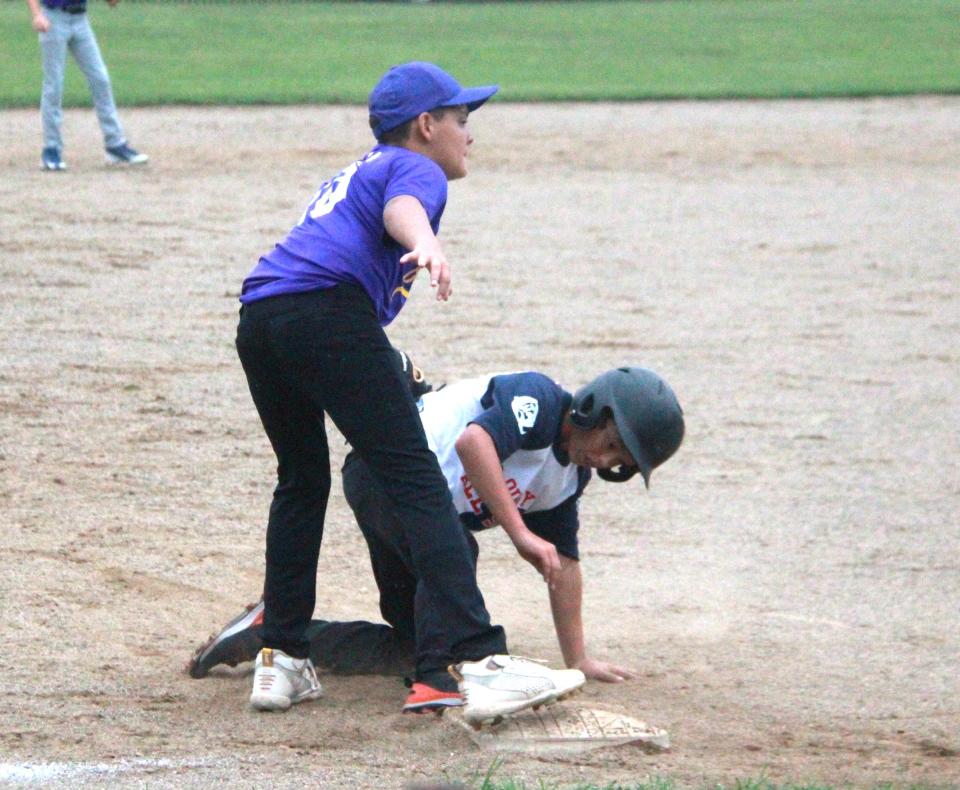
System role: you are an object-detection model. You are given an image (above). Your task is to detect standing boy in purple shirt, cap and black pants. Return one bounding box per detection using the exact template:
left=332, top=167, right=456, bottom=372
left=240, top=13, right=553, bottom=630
left=236, top=62, right=584, bottom=724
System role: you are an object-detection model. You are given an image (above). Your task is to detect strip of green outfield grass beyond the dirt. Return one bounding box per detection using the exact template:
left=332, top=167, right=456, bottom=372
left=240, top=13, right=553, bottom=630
left=0, top=0, right=960, bottom=107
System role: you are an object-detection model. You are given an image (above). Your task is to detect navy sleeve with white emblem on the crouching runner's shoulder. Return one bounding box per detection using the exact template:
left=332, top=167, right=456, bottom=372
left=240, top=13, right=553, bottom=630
left=471, top=373, right=564, bottom=461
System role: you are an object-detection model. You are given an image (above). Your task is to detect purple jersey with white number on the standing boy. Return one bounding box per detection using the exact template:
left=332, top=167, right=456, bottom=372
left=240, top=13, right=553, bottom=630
left=240, top=145, right=447, bottom=326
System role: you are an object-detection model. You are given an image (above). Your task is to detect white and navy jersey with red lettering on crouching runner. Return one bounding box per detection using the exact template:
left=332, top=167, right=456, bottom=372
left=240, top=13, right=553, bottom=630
left=418, top=373, right=590, bottom=559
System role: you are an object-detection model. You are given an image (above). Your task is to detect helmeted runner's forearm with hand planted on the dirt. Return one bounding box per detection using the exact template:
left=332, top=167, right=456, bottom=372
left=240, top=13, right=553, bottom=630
left=550, top=557, right=634, bottom=683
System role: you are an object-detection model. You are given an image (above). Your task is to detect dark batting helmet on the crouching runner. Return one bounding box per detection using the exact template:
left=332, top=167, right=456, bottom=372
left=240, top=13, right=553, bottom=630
left=570, top=367, right=684, bottom=488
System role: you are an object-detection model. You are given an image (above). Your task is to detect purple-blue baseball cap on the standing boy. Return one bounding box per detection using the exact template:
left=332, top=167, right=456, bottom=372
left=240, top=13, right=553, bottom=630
left=369, top=61, right=500, bottom=140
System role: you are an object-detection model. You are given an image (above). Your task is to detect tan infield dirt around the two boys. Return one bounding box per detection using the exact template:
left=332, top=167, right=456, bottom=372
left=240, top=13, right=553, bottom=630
left=0, top=98, right=960, bottom=788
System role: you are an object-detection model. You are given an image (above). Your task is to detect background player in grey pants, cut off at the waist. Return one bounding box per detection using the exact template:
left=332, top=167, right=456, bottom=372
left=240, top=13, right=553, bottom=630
left=27, top=0, right=148, bottom=170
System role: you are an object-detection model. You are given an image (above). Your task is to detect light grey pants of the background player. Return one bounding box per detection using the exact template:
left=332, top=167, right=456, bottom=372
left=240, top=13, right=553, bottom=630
left=40, top=8, right=126, bottom=151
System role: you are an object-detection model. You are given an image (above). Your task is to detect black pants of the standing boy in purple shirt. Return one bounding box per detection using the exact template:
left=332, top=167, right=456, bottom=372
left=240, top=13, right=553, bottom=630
left=237, top=285, right=506, bottom=679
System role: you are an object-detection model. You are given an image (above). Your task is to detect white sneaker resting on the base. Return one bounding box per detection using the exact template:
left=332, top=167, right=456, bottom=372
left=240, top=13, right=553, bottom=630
left=450, top=655, right=586, bottom=727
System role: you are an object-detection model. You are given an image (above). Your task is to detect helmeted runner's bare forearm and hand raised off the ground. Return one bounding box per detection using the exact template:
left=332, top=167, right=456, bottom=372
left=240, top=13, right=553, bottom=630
left=456, top=423, right=560, bottom=586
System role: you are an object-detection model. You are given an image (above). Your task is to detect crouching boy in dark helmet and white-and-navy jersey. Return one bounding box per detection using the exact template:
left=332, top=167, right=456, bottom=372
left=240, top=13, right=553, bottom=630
left=189, top=354, right=684, bottom=724
